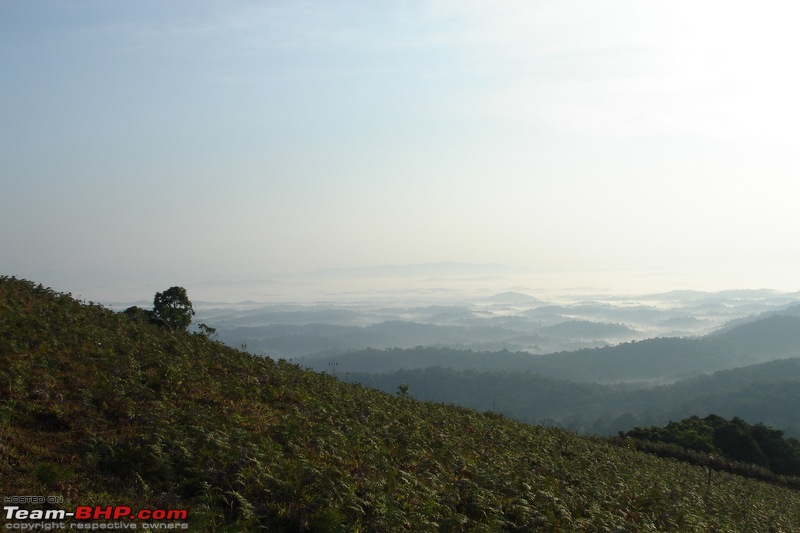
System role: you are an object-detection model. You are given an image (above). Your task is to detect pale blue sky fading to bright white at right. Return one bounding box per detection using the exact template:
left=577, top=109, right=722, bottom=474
left=0, top=0, right=800, bottom=299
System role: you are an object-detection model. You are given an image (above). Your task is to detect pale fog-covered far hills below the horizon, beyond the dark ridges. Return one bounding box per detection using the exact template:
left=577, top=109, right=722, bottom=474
left=197, top=272, right=797, bottom=357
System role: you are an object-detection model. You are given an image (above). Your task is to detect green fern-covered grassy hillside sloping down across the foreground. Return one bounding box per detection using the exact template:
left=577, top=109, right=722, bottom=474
left=0, top=278, right=800, bottom=531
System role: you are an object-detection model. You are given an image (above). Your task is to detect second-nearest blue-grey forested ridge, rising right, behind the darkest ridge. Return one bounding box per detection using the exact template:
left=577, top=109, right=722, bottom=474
left=300, top=315, right=800, bottom=383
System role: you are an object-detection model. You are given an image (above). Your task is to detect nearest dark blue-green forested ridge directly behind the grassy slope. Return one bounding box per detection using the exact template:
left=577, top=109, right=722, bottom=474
left=340, top=354, right=800, bottom=437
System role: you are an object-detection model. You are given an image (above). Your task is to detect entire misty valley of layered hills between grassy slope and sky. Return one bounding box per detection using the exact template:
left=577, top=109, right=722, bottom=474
left=178, top=270, right=800, bottom=436
